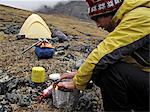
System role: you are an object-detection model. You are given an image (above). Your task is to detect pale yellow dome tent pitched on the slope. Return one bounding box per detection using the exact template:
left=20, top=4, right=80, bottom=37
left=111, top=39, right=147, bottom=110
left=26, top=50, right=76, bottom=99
left=19, top=14, right=51, bottom=39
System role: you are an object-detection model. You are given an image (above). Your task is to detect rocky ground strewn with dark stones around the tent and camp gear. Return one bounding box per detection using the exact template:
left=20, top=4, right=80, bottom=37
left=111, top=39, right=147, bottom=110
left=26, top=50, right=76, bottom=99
left=0, top=4, right=106, bottom=112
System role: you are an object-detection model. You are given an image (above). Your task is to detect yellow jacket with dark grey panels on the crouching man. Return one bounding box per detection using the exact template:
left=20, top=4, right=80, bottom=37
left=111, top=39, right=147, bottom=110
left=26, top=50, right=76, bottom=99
left=73, top=0, right=150, bottom=90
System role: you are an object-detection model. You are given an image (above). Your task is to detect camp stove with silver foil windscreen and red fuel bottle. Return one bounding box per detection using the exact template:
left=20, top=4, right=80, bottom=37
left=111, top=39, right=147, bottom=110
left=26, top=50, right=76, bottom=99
left=37, top=79, right=80, bottom=109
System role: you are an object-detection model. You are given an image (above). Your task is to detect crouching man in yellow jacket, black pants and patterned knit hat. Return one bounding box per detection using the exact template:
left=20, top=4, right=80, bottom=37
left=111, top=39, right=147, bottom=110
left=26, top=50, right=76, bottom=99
left=58, top=0, right=150, bottom=111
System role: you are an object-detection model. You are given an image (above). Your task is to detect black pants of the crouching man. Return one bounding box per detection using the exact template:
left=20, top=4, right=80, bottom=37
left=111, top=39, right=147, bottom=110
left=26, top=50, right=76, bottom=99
left=92, top=62, right=150, bottom=112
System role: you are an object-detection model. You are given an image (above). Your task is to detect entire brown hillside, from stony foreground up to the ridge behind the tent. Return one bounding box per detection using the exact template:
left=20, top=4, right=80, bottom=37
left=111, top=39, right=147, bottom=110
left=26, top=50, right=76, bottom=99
left=0, top=5, right=107, bottom=112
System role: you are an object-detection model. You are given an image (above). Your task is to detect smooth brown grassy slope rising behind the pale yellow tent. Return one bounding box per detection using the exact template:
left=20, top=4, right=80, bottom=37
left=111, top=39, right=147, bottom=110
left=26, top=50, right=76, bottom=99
left=0, top=5, right=104, bottom=40
